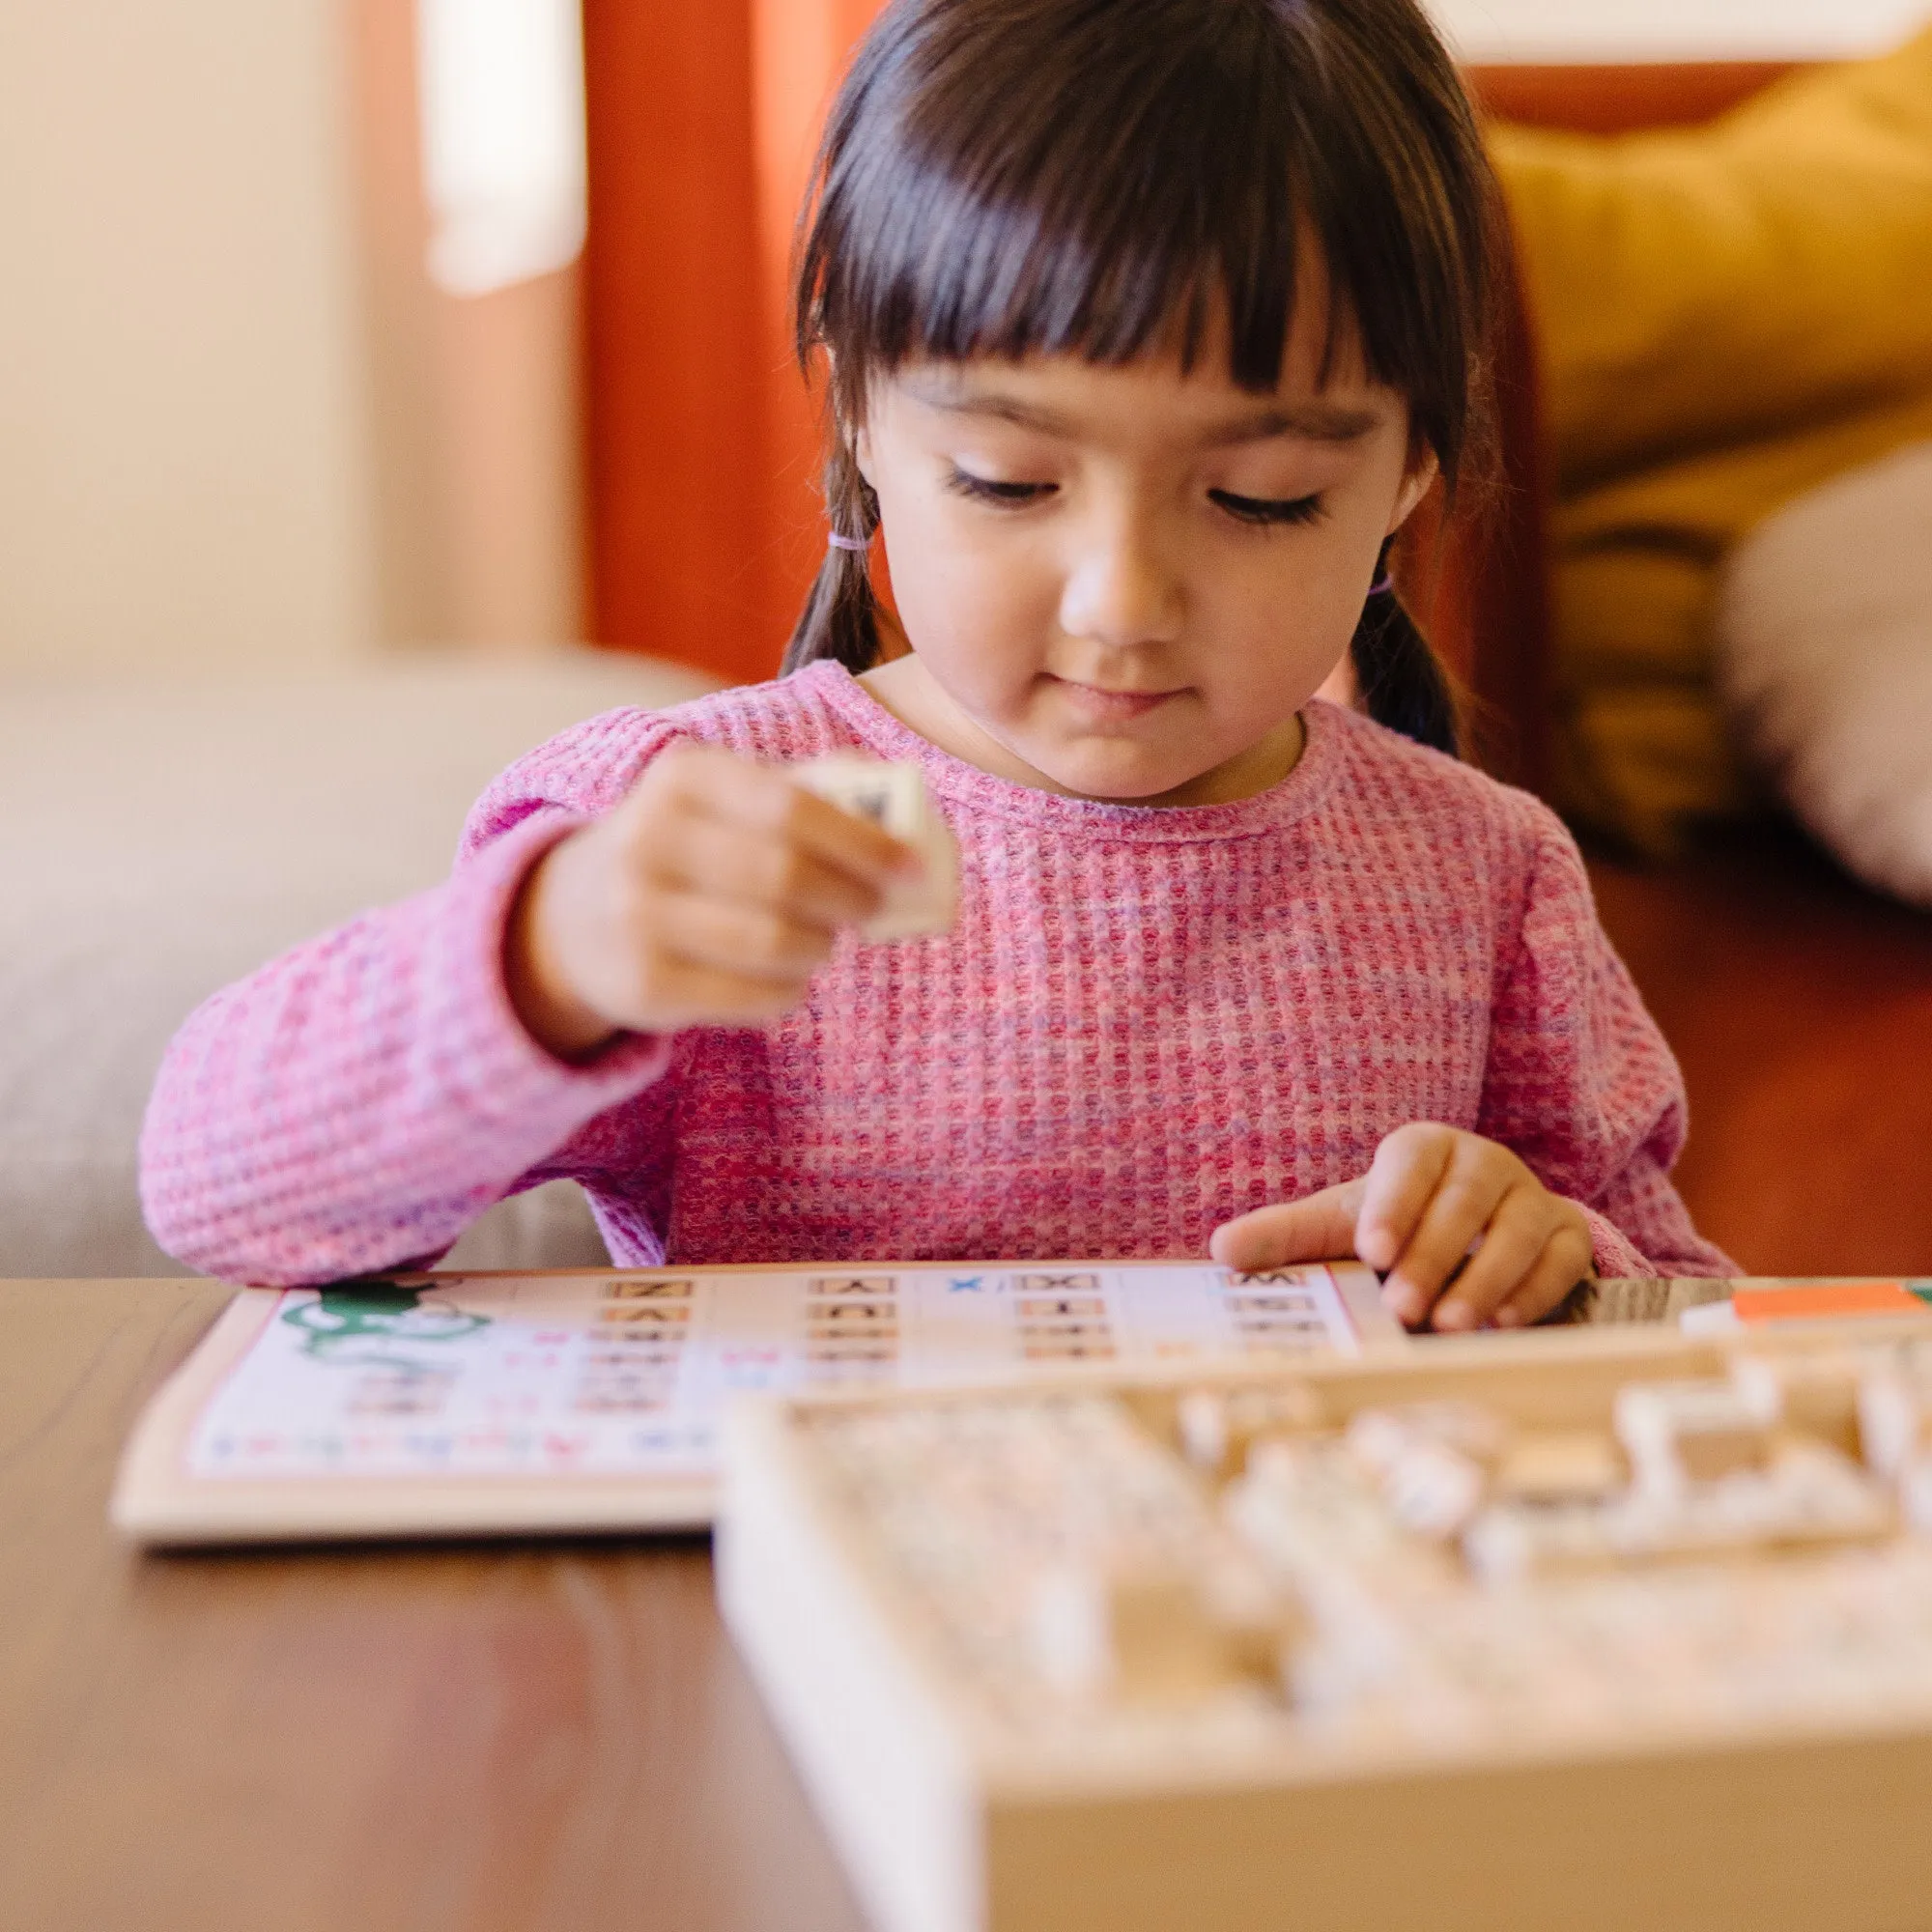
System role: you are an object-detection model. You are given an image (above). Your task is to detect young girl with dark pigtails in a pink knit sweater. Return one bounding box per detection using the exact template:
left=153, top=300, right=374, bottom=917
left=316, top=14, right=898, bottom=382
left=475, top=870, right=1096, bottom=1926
left=143, top=0, right=1727, bottom=1329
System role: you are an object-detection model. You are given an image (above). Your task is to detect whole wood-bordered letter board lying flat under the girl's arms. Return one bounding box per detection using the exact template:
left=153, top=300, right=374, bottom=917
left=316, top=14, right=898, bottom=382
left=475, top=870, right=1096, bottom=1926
left=112, top=1262, right=1405, bottom=1544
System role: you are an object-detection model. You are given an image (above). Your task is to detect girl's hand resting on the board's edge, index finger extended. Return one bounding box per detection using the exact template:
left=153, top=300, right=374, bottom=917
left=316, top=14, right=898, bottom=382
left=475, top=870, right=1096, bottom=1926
left=1209, top=1121, right=1596, bottom=1329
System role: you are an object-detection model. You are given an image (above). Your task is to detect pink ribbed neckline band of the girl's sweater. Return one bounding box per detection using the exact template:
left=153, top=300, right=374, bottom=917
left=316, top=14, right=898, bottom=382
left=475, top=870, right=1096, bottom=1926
left=794, top=659, right=1343, bottom=844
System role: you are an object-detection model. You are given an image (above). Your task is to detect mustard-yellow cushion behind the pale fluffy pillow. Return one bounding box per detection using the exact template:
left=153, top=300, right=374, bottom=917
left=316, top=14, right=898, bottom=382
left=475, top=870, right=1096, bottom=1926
left=1492, top=31, right=1932, bottom=850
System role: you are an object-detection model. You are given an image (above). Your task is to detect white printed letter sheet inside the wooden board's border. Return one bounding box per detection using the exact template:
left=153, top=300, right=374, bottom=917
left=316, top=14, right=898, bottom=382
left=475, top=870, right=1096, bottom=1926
left=187, top=1262, right=1401, bottom=1480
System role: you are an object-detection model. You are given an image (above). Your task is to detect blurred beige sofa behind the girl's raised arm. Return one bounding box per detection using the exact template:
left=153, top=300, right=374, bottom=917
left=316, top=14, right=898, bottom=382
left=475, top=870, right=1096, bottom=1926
left=0, top=651, right=709, bottom=1277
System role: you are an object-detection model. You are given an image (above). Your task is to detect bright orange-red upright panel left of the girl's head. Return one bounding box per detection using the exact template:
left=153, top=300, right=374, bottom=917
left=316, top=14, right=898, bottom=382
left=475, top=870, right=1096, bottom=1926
left=583, top=0, right=879, bottom=680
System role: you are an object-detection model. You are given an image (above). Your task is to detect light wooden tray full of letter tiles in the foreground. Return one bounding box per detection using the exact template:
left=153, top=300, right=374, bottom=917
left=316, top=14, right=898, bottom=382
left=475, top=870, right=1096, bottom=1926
left=719, top=1320, right=1932, bottom=1932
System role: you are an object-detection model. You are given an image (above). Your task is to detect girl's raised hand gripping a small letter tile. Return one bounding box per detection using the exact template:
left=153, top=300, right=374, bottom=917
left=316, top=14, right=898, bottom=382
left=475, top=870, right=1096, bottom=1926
left=504, top=744, right=922, bottom=1059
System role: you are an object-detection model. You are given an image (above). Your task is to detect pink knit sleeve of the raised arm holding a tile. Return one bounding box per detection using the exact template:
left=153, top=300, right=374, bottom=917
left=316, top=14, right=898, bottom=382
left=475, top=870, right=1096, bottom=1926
left=141, top=713, right=696, bottom=1287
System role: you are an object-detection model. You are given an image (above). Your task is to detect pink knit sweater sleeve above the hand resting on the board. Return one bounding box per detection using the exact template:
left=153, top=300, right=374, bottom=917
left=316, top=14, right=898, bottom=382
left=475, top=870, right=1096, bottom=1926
left=1476, top=810, right=1737, bottom=1275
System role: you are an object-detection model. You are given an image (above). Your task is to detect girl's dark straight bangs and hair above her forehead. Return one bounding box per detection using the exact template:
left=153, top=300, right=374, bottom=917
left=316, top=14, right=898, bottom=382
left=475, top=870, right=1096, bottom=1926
left=798, top=0, right=1376, bottom=404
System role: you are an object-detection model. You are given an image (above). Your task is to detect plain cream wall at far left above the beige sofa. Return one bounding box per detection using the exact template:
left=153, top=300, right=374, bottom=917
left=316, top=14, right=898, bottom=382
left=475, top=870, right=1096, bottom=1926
left=0, top=0, right=375, bottom=670
